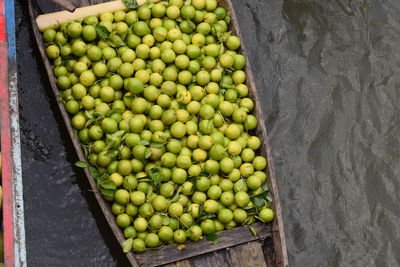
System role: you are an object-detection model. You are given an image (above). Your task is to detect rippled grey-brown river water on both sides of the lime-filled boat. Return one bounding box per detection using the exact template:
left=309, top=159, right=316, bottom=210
left=16, top=0, right=400, bottom=267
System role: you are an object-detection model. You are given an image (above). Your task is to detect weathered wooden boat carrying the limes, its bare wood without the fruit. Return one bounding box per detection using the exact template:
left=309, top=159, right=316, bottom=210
left=29, top=0, right=288, bottom=267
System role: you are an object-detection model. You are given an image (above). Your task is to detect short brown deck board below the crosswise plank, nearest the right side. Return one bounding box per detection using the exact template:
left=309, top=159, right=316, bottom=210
left=228, top=241, right=269, bottom=267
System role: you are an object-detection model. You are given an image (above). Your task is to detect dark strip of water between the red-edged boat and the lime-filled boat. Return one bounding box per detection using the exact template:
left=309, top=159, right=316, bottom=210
left=16, top=1, right=127, bottom=266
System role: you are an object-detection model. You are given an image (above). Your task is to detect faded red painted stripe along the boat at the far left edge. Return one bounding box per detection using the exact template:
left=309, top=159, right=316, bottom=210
left=0, top=0, right=15, bottom=267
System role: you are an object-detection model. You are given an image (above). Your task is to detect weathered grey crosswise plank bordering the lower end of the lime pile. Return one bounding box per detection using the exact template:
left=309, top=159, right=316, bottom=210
left=135, top=222, right=272, bottom=267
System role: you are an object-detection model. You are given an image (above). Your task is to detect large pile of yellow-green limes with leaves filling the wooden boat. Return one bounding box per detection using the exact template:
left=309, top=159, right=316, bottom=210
left=43, top=0, right=274, bottom=252
